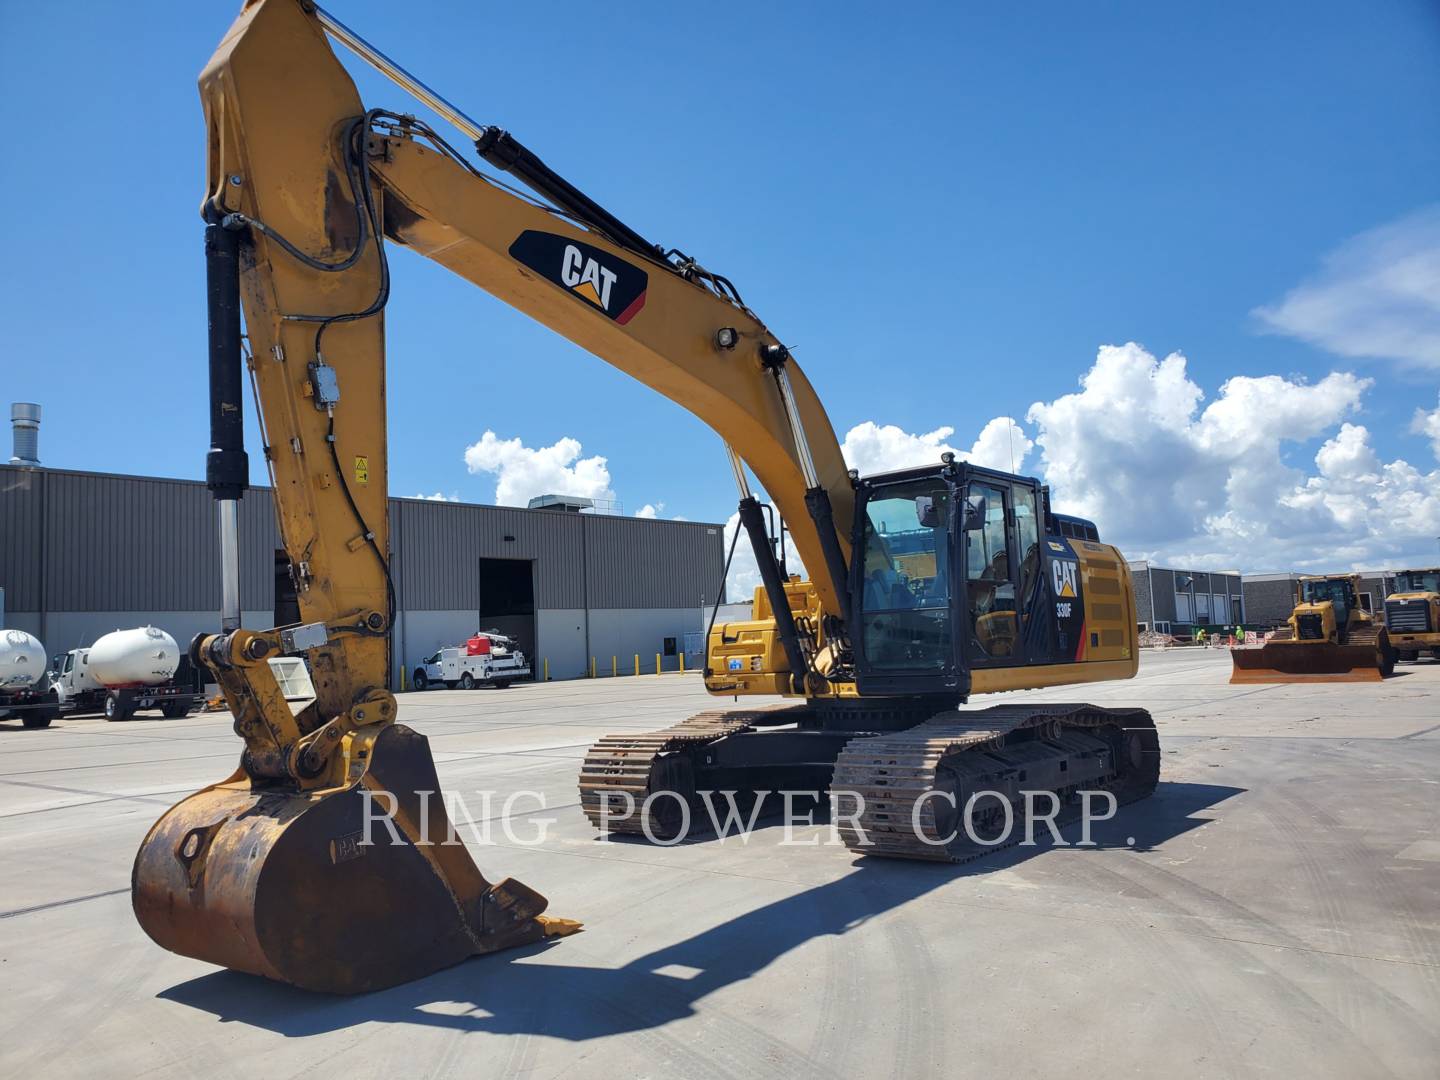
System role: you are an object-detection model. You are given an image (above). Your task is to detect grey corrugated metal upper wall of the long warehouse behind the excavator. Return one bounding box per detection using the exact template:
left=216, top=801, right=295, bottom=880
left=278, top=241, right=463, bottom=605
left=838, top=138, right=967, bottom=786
left=0, top=465, right=724, bottom=612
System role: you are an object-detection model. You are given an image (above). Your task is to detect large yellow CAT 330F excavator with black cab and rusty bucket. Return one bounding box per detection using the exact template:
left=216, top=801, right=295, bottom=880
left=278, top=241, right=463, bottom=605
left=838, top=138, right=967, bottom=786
left=132, top=0, right=1159, bottom=992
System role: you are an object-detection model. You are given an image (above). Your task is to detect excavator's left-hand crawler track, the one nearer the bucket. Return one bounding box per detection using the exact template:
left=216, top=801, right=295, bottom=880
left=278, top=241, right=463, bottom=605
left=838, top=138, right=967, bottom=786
left=580, top=706, right=806, bottom=840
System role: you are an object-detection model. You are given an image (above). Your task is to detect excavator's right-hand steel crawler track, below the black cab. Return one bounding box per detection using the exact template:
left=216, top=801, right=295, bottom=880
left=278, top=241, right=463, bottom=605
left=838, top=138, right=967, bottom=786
left=831, top=704, right=1159, bottom=863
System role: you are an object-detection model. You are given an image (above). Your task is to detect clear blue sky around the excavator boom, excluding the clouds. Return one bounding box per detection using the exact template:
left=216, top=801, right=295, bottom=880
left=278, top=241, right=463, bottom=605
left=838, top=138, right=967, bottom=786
left=0, top=0, right=1440, bottom=570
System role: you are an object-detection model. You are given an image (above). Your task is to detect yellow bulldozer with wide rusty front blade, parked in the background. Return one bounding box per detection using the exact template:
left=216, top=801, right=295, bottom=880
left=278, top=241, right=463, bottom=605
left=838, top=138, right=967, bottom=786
left=1230, top=575, right=1395, bottom=683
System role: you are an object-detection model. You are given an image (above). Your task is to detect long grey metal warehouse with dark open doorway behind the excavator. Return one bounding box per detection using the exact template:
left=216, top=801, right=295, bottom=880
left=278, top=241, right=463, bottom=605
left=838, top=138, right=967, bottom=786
left=0, top=465, right=724, bottom=684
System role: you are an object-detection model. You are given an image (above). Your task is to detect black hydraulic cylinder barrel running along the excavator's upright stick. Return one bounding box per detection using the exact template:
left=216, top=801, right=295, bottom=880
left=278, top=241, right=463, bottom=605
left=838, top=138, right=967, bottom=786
left=204, top=222, right=251, bottom=500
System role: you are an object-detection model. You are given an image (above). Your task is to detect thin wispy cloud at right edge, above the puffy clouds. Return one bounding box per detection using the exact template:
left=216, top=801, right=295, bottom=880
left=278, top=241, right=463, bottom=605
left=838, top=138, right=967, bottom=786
left=1253, top=206, right=1440, bottom=367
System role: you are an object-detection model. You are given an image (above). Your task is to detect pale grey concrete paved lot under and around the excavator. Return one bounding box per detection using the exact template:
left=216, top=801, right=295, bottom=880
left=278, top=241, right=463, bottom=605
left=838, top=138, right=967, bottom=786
left=0, top=651, right=1440, bottom=1077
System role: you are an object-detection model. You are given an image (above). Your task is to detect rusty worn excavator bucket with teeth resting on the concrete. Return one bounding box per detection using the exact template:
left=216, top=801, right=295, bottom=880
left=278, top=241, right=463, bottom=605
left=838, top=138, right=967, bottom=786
left=131, top=724, right=579, bottom=994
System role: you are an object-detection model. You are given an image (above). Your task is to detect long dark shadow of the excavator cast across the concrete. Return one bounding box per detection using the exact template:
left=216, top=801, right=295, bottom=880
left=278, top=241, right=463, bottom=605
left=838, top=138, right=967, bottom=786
left=158, top=782, right=1243, bottom=1056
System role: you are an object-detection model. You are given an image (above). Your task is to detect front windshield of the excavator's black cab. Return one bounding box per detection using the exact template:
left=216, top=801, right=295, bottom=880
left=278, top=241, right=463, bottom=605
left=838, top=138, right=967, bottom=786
left=860, top=478, right=950, bottom=671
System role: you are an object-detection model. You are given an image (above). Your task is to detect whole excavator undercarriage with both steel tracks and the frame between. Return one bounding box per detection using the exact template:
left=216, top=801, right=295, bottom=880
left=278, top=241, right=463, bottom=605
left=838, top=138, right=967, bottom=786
left=580, top=704, right=1159, bottom=863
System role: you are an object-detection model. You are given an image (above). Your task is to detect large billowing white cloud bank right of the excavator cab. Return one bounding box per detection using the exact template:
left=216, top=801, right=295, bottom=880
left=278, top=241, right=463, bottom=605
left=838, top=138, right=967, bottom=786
left=1027, top=343, right=1440, bottom=572
